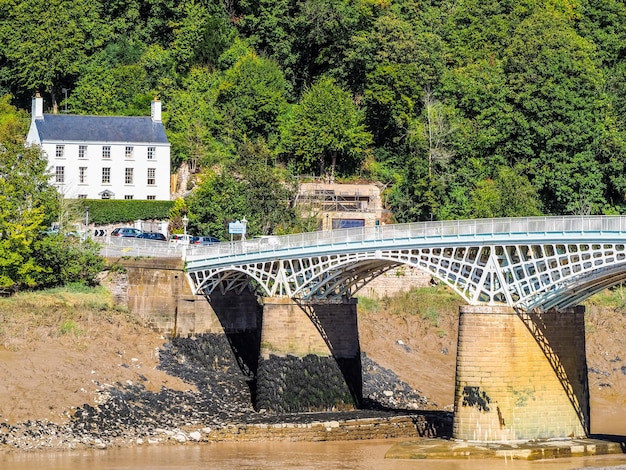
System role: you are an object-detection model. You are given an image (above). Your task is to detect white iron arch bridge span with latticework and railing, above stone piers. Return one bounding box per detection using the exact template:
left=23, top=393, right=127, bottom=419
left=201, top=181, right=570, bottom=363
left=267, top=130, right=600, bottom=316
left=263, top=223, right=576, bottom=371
left=185, top=216, right=626, bottom=311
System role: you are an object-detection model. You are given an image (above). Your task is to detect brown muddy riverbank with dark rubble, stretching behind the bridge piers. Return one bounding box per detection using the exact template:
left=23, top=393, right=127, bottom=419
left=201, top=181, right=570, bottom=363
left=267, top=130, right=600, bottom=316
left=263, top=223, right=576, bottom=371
left=0, top=286, right=626, bottom=451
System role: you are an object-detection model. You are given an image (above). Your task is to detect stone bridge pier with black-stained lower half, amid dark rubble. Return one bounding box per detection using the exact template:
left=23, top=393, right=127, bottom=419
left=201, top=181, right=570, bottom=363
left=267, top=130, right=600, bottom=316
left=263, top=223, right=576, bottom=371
left=256, top=297, right=362, bottom=412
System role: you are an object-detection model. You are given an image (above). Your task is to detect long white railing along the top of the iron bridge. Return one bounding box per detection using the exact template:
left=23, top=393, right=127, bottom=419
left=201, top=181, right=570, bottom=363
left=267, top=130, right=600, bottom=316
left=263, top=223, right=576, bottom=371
left=186, top=216, right=626, bottom=260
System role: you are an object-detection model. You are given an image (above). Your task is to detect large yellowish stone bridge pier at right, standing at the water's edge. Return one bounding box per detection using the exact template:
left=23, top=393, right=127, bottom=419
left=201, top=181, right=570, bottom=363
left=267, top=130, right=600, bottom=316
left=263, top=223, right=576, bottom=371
left=453, top=306, right=589, bottom=441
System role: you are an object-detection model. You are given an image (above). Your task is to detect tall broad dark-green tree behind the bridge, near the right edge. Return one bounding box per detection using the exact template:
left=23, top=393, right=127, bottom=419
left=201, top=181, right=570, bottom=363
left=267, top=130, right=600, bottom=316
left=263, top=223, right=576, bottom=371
left=501, top=11, right=607, bottom=214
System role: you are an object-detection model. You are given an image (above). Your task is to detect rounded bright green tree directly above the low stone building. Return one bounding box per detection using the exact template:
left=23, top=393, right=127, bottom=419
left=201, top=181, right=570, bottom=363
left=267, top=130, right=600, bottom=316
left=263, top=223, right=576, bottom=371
left=282, top=77, right=372, bottom=179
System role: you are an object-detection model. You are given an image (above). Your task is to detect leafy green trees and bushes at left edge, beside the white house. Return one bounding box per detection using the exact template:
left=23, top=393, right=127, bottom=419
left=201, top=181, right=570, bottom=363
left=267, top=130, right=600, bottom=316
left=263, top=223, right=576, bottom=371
left=0, top=97, right=103, bottom=293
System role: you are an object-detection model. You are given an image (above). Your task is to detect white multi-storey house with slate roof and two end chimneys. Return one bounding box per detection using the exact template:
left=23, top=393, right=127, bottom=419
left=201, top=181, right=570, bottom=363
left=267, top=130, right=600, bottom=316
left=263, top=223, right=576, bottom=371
left=26, top=93, right=170, bottom=200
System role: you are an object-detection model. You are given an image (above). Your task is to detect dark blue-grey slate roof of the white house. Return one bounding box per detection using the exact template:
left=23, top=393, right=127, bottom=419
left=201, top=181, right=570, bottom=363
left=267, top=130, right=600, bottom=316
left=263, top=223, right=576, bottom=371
left=35, top=114, right=169, bottom=144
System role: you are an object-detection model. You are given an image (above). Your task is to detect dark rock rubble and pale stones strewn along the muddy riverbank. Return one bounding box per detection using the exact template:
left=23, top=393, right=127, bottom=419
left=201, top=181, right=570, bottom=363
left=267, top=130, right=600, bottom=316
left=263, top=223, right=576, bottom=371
left=0, top=335, right=444, bottom=450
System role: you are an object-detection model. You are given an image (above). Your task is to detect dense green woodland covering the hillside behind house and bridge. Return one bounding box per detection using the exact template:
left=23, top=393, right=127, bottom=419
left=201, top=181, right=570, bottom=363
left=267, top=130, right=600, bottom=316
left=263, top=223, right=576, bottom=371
left=0, top=0, right=626, bottom=290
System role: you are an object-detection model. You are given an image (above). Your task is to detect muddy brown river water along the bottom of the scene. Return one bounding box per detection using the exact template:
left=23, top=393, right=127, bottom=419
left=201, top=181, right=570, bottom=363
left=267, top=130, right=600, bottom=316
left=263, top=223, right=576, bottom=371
left=0, top=439, right=626, bottom=470
